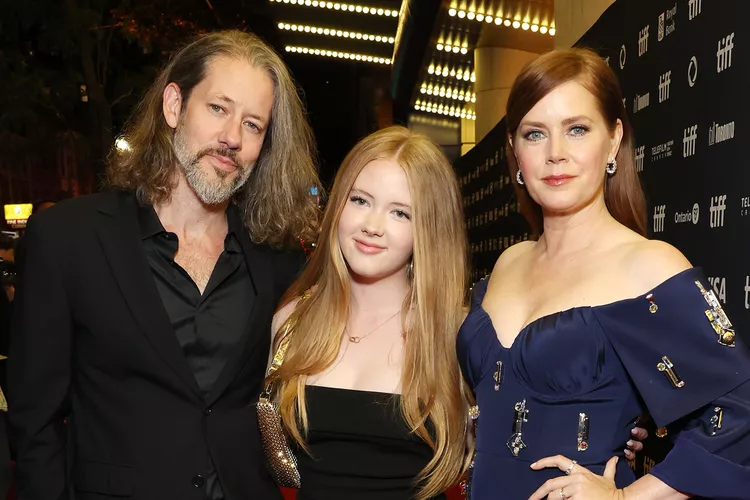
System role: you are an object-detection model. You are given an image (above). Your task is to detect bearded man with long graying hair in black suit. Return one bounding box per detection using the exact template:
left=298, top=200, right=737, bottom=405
left=9, top=31, right=318, bottom=500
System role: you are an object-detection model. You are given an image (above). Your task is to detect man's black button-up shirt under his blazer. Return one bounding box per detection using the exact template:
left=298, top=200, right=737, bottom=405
left=139, top=201, right=255, bottom=500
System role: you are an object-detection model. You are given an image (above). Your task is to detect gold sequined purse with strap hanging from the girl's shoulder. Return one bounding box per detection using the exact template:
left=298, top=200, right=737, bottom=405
left=257, top=293, right=310, bottom=488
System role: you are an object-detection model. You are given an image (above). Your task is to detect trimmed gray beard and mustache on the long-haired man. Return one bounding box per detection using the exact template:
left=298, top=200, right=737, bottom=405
left=174, top=124, right=253, bottom=205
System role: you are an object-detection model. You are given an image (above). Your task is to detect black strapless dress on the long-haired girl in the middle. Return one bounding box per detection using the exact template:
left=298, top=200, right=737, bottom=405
left=297, top=386, right=445, bottom=500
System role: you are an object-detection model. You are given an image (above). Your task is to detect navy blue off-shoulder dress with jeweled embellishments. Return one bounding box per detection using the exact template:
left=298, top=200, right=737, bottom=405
left=457, top=268, right=750, bottom=500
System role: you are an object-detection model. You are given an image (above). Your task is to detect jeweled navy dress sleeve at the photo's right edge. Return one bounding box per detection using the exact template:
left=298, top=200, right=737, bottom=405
left=597, top=269, right=750, bottom=500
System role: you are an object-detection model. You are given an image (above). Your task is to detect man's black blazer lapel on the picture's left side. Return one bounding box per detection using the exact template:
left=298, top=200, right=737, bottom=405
left=97, top=193, right=203, bottom=400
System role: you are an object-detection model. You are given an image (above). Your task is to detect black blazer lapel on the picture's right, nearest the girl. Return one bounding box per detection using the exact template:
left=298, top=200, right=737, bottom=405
left=206, top=231, right=276, bottom=406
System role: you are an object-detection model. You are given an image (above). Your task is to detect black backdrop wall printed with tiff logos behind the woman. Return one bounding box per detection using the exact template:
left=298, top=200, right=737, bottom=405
left=455, top=0, right=750, bottom=482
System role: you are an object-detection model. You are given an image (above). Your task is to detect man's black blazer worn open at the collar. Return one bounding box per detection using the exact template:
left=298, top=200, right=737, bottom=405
left=8, top=192, right=301, bottom=500
